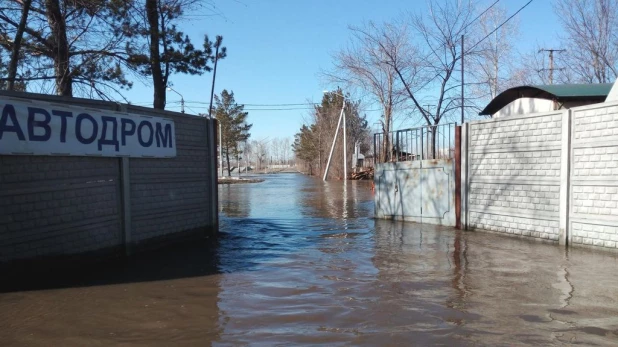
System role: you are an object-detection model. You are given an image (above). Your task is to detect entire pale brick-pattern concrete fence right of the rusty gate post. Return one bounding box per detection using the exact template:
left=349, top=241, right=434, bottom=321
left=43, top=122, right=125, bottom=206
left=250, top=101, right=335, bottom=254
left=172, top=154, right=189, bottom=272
left=461, top=102, right=618, bottom=249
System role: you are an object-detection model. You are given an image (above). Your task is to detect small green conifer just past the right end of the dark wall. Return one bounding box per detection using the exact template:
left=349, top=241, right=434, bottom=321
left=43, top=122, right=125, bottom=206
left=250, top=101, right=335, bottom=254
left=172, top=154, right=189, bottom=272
left=214, top=89, right=253, bottom=175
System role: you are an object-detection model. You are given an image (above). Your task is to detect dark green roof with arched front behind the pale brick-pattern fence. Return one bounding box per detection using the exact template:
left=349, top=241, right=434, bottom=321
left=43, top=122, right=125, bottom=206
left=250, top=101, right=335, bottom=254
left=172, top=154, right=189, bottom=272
left=479, top=83, right=613, bottom=115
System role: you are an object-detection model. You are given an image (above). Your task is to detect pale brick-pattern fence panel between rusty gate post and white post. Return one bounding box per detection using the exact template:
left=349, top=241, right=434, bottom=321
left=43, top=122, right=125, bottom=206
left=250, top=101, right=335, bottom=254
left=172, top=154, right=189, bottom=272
left=466, top=111, right=564, bottom=241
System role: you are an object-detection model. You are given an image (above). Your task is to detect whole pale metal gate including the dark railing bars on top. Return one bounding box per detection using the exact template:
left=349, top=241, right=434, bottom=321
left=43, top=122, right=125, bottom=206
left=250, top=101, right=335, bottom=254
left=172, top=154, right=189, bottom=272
left=374, top=123, right=456, bottom=225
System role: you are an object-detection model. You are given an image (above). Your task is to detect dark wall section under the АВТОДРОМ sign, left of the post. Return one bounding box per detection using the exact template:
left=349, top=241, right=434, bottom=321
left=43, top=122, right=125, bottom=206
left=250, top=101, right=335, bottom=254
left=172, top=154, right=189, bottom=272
left=0, top=156, right=122, bottom=261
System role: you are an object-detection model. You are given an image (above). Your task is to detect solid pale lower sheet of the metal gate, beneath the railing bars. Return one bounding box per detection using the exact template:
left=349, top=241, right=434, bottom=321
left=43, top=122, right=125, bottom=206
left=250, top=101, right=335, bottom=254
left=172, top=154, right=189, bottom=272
left=374, top=159, right=455, bottom=226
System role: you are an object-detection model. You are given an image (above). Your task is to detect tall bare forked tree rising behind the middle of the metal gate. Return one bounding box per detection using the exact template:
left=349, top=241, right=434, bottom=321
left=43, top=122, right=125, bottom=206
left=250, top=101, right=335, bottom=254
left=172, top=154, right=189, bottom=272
left=379, top=1, right=476, bottom=155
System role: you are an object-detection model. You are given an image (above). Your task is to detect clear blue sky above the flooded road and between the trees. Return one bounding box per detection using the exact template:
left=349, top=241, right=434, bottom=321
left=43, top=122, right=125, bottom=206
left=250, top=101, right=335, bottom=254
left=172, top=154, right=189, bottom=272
left=125, top=0, right=559, bottom=140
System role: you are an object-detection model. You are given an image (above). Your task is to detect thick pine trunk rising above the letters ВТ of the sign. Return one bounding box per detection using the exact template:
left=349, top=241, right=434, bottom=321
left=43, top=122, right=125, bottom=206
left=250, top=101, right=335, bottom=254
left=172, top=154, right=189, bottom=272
left=45, top=0, right=73, bottom=96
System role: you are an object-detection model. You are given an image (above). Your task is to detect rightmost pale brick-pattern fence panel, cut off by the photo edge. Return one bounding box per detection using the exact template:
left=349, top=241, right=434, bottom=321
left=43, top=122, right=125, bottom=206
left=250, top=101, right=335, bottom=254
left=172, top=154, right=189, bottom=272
left=569, top=102, right=618, bottom=249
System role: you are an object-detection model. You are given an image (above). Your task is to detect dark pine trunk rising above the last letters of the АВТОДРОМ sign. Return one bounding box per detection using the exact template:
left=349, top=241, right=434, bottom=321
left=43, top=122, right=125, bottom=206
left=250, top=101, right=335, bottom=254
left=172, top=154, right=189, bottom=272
left=146, top=0, right=167, bottom=110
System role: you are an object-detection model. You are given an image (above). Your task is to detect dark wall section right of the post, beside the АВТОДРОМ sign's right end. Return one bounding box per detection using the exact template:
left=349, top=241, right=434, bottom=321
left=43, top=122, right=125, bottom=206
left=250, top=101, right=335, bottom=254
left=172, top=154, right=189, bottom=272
left=130, top=116, right=217, bottom=244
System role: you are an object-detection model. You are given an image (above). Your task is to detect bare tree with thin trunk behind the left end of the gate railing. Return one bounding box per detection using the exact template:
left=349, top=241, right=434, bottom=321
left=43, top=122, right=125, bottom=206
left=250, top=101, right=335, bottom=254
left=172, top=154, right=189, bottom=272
left=325, top=22, right=407, bottom=161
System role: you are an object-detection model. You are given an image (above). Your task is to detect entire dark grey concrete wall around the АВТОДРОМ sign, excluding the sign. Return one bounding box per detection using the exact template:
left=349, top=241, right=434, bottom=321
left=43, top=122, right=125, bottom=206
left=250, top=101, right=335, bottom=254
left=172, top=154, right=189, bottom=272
left=0, top=92, right=218, bottom=263
